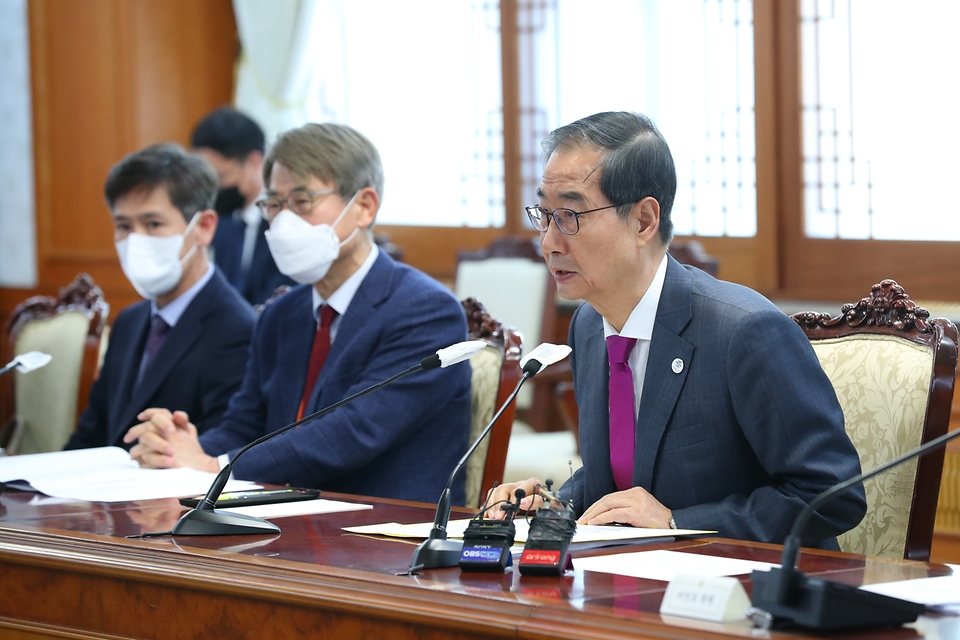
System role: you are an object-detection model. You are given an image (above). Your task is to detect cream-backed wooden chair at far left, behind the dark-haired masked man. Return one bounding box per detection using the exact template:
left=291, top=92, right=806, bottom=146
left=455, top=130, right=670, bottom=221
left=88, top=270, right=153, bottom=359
left=3, top=273, right=110, bottom=453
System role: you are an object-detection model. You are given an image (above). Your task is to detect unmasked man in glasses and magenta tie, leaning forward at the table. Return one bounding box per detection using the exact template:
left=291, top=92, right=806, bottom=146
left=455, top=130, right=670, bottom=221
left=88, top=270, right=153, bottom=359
left=493, top=113, right=866, bottom=548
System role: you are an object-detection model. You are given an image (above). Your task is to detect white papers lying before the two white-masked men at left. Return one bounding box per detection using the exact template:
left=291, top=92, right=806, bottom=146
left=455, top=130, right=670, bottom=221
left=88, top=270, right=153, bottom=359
left=0, top=447, right=260, bottom=502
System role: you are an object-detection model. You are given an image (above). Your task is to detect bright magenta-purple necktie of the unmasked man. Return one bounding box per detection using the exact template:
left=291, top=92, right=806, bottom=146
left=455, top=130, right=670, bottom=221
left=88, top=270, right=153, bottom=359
left=607, top=336, right=637, bottom=491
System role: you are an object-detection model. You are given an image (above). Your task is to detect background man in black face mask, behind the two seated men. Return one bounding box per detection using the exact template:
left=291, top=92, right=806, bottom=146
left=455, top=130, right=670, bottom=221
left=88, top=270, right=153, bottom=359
left=190, top=107, right=295, bottom=304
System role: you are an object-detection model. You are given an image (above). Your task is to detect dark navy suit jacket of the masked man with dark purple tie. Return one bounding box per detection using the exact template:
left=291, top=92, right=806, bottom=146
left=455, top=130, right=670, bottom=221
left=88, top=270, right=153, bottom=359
left=66, top=271, right=256, bottom=449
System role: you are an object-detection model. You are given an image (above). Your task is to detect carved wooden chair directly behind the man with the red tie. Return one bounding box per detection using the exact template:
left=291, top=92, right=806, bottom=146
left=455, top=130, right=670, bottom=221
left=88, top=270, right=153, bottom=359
left=463, top=298, right=522, bottom=507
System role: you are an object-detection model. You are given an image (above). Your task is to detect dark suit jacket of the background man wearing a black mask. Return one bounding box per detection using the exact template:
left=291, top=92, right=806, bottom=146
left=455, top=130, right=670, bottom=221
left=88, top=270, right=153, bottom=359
left=212, top=216, right=296, bottom=305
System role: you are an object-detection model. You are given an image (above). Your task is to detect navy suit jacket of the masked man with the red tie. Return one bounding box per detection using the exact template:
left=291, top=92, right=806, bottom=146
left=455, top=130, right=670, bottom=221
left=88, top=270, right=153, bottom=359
left=200, top=252, right=470, bottom=504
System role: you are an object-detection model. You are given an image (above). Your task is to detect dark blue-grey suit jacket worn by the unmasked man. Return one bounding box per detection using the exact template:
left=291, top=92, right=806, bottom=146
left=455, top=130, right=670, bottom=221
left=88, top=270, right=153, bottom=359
left=561, top=258, right=866, bottom=548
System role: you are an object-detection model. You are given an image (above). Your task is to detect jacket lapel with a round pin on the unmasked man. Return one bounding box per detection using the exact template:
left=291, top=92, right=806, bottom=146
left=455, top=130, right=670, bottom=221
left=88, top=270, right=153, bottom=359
left=632, top=258, right=693, bottom=491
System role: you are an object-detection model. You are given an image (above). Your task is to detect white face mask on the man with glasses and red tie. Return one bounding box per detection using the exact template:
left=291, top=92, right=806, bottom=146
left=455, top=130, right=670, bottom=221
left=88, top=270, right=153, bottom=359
left=264, top=191, right=360, bottom=284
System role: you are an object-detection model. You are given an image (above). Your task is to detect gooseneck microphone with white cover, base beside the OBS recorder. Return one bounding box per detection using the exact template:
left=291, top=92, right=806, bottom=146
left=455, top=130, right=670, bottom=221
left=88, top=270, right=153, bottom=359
left=410, top=342, right=572, bottom=573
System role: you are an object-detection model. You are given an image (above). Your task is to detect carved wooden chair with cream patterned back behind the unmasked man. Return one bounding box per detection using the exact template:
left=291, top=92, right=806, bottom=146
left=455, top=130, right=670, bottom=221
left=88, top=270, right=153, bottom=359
left=791, top=280, right=957, bottom=560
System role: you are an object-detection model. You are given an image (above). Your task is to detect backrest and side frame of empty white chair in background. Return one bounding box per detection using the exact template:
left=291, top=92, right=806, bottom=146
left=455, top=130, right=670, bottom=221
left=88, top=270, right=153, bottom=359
left=455, top=236, right=576, bottom=431
